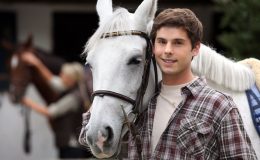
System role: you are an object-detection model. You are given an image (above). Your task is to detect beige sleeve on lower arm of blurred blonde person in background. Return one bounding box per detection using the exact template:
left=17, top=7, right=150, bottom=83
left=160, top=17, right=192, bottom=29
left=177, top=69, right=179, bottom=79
left=48, top=92, right=81, bottom=118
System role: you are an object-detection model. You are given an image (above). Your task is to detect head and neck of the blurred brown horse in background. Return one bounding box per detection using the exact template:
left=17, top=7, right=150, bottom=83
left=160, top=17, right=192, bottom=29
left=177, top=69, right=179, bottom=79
left=9, top=37, right=65, bottom=104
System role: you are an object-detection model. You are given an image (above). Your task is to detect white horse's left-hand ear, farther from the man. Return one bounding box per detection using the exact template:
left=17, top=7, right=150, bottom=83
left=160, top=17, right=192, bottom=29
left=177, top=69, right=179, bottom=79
left=96, top=0, right=113, bottom=25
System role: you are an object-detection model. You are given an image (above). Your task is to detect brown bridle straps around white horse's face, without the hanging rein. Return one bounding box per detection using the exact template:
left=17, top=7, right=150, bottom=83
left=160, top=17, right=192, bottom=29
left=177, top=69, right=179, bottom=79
left=91, top=30, right=158, bottom=115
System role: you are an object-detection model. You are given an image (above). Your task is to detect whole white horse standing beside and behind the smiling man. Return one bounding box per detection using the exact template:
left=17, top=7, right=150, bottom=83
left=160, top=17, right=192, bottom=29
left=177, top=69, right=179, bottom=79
left=80, top=0, right=260, bottom=158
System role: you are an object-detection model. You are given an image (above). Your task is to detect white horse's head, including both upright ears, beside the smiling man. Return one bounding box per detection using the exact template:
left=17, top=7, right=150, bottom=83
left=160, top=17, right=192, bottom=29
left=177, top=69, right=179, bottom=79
left=81, top=0, right=157, bottom=158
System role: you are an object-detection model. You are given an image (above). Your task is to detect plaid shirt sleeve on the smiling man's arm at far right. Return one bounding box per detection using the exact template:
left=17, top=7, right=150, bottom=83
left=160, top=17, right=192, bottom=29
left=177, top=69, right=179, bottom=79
left=219, top=108, right=257, bottom=160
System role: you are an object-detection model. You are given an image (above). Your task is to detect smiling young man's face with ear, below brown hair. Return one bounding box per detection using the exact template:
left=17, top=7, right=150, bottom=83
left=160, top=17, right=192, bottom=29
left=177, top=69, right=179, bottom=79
left=153, top=27, right=199, bottom=84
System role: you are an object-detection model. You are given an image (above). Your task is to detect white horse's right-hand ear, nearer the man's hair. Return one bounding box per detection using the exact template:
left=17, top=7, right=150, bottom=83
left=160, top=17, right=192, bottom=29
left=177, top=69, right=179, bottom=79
left=134, top=0, right=158, bottom=30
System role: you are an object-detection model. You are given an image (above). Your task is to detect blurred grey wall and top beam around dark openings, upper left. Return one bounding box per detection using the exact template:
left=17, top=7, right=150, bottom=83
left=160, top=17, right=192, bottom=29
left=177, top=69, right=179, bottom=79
left=0, top=3, right=95, bottom=51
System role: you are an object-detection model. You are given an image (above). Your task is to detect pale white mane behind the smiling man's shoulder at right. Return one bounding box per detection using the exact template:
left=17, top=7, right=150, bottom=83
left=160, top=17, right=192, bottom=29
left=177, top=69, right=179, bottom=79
left=192, top=45, right=255, bottom=91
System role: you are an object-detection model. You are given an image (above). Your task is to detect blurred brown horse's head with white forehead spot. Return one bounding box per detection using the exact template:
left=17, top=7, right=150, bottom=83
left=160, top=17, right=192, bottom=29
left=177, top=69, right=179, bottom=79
left=9, top=37, right=32, bottom=103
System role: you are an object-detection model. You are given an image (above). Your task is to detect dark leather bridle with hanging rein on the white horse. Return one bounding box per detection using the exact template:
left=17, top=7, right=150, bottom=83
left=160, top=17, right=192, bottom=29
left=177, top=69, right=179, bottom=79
left=91, top=30, right=158, bottom=159
